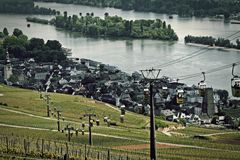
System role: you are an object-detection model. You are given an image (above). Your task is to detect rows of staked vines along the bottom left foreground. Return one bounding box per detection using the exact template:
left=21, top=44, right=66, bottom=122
left=0, top=135, right=148, bottom=160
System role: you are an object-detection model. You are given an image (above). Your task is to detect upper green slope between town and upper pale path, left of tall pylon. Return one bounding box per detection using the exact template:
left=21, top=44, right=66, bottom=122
left=0, top=85, right=149, bottom=128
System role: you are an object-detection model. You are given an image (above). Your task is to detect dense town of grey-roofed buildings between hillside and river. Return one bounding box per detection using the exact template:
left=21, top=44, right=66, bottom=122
left=0, top=54, right=233, bottom=124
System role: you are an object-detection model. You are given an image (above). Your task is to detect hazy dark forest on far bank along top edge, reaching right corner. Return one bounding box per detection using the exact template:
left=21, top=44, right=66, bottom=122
left=35, top=0, right=240, bottom=18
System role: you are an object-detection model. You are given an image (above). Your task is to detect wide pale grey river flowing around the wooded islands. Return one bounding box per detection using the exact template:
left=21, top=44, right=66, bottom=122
left=0, top=3, right=240, bottom=95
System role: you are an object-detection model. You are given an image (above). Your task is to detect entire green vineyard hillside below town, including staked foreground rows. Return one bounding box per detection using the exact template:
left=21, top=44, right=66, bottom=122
left=0, top=85, right=240, bottom=160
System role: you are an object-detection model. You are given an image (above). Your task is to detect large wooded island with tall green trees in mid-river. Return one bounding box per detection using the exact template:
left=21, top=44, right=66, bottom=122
left=50, top=12, right=178, bottom=41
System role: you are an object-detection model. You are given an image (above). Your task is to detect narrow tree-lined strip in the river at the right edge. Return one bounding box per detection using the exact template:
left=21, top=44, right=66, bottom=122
left=185, top=36, right=240, bottom=49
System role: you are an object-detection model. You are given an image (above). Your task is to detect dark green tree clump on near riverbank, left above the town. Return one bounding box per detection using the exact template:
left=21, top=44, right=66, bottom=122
left=0, top=28, right=66, bottom=62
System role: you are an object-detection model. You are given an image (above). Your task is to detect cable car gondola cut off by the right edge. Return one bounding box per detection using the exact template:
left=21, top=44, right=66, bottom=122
left=231, top=63, right=240, bottom=97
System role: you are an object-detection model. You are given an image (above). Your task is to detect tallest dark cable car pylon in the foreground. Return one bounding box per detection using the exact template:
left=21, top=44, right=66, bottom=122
left=141, top=68, right=161, bottom=160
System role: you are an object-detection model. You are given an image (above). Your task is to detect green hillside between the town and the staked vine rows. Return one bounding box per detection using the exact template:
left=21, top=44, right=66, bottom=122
left=0, top=85, right=240, bottom=159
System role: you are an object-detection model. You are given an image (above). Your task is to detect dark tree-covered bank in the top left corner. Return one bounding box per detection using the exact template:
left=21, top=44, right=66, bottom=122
left=0, top=0, right=60, bottom=15
